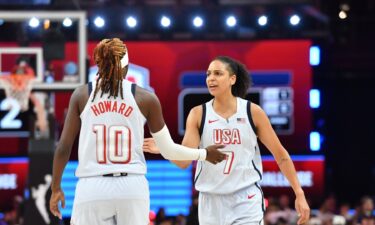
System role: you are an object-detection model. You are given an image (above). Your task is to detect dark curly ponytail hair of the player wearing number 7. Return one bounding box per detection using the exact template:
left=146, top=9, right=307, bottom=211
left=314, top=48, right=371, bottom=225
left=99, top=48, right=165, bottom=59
left=213, top=56, right=252, bottom=98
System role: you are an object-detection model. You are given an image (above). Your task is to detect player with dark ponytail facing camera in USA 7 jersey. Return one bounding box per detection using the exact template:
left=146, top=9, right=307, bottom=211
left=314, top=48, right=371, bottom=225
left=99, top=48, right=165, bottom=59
left=144, top=56, right=310, bottom=225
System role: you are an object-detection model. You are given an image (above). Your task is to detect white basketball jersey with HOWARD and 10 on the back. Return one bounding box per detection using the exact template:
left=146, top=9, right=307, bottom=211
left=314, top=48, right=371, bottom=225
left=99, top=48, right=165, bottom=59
left=76, top=80, right=146, bottom=177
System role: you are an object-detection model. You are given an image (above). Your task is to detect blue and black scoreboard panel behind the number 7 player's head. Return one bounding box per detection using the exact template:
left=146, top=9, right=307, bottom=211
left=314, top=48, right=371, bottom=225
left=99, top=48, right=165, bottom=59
left=178, top=71, right=294, bottom=135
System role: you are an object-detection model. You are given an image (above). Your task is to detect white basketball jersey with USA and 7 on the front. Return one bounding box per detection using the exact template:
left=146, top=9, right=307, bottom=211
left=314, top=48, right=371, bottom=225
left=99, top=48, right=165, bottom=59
left=195, top=98, right=262, bottom=194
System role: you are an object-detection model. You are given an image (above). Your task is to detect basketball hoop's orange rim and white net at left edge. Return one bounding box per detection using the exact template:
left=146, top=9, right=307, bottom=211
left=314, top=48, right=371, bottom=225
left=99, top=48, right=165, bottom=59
left=0, top=74, right=35, bottom=111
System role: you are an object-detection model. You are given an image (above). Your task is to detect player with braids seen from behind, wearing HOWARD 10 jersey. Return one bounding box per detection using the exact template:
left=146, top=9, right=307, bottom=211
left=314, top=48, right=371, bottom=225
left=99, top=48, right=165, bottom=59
left=50, top=38, right=225, bottom=225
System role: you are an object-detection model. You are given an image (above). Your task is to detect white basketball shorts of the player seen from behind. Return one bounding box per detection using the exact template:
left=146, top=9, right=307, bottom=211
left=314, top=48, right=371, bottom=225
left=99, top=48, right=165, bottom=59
left=70, top=174, right=150, bottom=225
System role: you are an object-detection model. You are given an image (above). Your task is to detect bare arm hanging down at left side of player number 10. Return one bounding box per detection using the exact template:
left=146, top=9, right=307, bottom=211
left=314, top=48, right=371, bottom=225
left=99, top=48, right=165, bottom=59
left=50, top=85, right=82, bottom=219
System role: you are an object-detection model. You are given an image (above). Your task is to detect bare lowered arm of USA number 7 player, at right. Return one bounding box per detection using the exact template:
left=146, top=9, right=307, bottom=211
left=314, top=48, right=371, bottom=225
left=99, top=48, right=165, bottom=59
left=250, top=103, right=310, bottom=224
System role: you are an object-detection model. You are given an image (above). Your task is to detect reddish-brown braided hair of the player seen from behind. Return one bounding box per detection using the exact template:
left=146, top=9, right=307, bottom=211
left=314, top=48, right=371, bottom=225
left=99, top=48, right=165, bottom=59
left=92, top=38, right=127, bottom=101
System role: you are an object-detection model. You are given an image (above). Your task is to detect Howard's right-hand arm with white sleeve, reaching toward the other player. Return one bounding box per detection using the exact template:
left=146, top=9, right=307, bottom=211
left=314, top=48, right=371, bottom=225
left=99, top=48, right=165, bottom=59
left=136, top=89, right=226, bottom=164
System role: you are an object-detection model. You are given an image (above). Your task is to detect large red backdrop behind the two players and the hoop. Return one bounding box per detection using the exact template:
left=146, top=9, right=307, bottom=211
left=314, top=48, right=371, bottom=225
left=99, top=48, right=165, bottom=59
left=0, top=40, right=312, bottom=155
